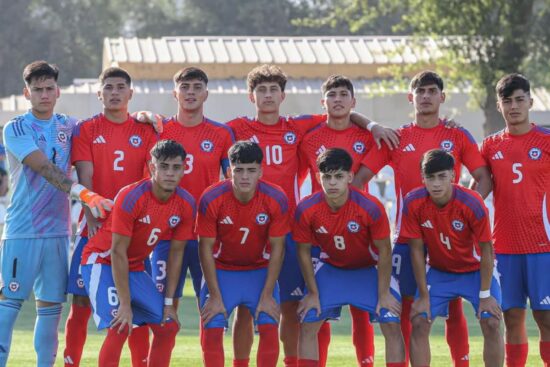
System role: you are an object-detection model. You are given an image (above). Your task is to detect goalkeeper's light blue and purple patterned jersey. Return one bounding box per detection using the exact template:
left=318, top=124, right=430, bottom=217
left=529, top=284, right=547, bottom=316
left=2, top=111, right=76, bottom=239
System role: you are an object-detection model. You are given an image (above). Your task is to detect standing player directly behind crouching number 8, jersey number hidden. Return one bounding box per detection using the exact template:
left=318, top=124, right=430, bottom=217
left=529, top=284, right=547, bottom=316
left=299, top=75, right=382, bottom=366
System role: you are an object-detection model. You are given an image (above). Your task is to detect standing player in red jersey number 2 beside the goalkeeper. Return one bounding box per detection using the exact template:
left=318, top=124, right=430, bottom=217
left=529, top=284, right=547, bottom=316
left=63, top=67, right=157, bottom=367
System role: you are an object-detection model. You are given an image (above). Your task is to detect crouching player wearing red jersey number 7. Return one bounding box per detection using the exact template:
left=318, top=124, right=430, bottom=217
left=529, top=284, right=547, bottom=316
left=199, top=141, right=290, bottom=367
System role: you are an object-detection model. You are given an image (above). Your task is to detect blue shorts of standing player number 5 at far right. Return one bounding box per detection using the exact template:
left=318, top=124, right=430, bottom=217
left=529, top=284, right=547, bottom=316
left=497, top=253, right=550, bottom=311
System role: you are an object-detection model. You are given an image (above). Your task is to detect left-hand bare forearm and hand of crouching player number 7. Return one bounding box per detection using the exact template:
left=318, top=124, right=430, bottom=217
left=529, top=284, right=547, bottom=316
left=199, top=236, right=227, bottom=325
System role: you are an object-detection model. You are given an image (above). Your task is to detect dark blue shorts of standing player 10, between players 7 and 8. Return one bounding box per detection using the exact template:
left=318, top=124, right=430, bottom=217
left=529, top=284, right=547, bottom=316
left=278, top=233, right=321, bottom=302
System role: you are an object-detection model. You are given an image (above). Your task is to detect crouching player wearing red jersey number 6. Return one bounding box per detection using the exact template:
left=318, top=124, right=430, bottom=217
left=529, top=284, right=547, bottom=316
left=82, top=140, right=195, bottom=367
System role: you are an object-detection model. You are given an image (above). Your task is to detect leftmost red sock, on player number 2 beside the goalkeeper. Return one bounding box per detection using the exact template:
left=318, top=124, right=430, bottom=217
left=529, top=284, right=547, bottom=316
left=63, top=304, right=92, bottom=367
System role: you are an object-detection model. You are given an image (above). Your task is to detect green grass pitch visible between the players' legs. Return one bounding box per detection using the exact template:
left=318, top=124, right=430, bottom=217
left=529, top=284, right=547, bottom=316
left=8, top=282, right=542, bottom=367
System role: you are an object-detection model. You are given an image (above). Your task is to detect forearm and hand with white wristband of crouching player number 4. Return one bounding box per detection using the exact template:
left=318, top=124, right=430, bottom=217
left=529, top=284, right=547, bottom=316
left=477, top=242, right=502, bottom=320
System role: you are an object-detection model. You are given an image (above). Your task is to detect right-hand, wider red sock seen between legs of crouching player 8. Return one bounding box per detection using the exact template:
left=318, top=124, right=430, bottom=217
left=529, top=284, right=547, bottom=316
left=349, top=306, right=374, bottom=366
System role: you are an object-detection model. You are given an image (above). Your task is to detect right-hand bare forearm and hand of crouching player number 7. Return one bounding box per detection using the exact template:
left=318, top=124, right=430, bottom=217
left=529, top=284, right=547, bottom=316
left=254, top=236, right=285, bottom=321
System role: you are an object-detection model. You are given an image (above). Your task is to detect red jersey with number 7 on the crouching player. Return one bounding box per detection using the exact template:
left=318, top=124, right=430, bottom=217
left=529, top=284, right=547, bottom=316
left=197, top=180, right=290, bottom=270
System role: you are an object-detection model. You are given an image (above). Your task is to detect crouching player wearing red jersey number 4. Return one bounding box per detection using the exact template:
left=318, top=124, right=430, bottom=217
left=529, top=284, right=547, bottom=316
left=402, top=149, right=504, bottom=366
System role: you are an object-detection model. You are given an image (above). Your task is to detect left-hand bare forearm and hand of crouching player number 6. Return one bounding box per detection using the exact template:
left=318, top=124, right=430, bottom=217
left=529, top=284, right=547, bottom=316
left=111, top=233, right=133, bottom=334
